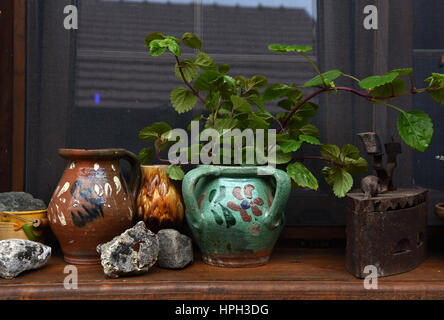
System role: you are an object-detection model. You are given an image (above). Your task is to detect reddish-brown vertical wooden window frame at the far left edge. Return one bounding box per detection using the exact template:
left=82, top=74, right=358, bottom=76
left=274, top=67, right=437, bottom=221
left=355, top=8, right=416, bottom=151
left=0, top=0, right=26, bottom=191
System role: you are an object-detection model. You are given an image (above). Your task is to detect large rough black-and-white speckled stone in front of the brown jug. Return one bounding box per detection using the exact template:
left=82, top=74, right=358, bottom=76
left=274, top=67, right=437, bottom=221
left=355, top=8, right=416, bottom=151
left=97, top=221, right=159, bottom=278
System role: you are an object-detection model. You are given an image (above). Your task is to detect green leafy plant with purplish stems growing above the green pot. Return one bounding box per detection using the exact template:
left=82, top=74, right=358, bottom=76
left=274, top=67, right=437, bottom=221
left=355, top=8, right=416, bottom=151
left=139, top=32, right=444, bottom=197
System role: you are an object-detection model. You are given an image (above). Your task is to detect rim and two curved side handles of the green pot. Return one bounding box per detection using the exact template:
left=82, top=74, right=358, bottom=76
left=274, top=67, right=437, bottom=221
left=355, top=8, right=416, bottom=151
left=182, top=166, right=291, bottom=230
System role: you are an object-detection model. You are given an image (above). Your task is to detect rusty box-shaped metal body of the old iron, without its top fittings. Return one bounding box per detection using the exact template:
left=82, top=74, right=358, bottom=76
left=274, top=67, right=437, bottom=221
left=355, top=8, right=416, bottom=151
left=346, top=189, right=428, bottom=278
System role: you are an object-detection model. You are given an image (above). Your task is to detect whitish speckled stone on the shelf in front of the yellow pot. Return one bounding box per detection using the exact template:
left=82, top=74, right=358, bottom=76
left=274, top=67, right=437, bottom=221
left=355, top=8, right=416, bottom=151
left=0, top=239, right=51, bottom=279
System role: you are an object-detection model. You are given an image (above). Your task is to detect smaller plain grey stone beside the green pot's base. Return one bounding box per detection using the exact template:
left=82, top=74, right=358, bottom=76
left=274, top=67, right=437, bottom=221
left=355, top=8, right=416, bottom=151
left=157, top=229, right=193, bottom=269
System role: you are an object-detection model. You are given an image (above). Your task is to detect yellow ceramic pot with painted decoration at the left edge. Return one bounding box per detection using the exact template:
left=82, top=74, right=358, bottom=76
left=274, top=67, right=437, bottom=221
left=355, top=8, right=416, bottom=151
left=0, top=210, right=48, bottom=242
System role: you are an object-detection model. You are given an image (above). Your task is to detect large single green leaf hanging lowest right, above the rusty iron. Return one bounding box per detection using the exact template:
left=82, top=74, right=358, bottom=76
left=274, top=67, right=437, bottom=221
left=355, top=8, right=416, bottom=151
left=398, top=110, right=433, bottom=152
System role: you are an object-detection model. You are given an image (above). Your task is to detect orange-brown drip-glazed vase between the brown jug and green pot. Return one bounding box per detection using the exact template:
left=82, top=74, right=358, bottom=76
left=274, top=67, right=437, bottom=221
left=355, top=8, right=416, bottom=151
left=136, top=165, right=184, bottom=233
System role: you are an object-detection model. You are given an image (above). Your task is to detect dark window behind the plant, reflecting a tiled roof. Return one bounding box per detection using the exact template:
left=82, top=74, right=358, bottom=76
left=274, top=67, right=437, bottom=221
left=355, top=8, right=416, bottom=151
left=26, top=0, right=444, bottom=225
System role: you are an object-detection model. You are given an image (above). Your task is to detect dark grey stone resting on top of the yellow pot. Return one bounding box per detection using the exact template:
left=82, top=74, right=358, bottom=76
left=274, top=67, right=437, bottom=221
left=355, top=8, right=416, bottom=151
left=0, top=192, right=47, bottom=211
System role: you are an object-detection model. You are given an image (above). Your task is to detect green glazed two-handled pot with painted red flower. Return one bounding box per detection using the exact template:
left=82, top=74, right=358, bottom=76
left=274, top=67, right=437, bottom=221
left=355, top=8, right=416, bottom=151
left=182, top=166, right=291, bottom=267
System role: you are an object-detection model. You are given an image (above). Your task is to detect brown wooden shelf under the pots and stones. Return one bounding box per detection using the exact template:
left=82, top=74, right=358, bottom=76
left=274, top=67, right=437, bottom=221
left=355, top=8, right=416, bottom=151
left=0, top=240, right=444, bottom=299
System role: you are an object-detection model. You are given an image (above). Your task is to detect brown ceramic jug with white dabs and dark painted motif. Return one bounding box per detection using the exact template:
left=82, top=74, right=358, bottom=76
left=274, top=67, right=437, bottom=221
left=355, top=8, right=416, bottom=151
left=48, top=149, right=140, bottom=264
